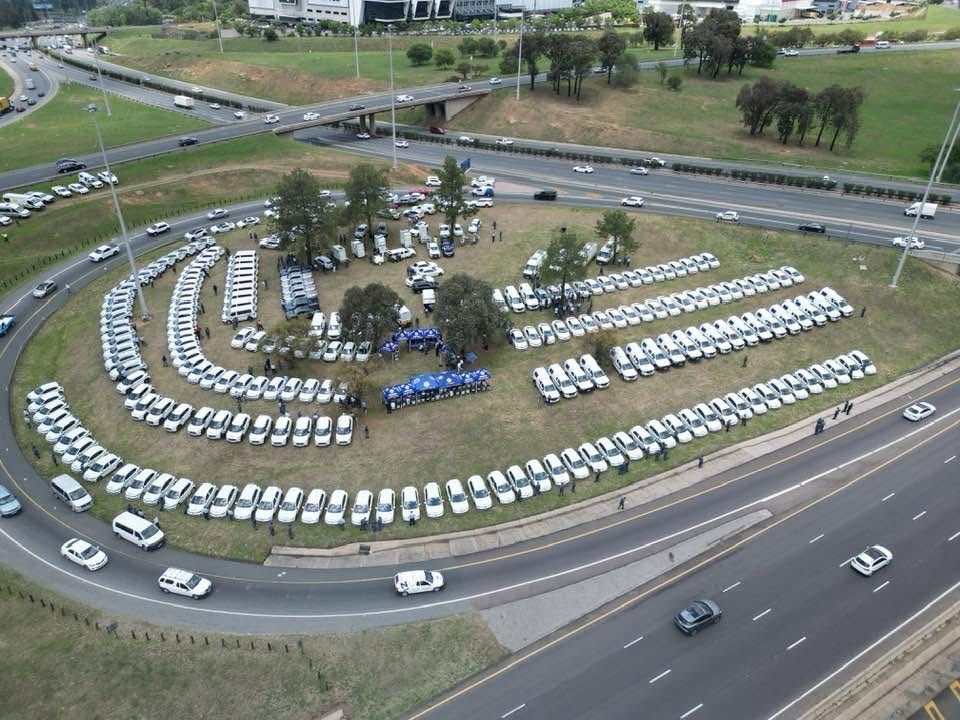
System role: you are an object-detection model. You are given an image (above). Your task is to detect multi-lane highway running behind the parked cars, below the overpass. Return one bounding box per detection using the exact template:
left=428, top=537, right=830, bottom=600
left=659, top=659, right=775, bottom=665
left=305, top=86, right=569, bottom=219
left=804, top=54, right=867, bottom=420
left=295, top=128, right=960, bottom=253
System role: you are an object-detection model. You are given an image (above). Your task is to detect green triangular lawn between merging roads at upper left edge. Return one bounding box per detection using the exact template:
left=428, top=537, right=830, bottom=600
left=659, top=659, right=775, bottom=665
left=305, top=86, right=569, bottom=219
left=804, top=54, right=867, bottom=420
left=0, top=85, right=209, bottom=172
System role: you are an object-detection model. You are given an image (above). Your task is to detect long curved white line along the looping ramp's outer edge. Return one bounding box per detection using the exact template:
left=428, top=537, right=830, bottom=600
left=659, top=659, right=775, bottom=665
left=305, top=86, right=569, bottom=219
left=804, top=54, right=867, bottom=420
left=7, top=408, right=960, bottom=620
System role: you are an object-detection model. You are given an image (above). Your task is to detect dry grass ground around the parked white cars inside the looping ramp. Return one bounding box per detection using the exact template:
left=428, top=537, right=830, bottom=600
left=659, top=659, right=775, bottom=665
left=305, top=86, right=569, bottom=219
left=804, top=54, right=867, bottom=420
left=14, top=202, right=960, bottom=560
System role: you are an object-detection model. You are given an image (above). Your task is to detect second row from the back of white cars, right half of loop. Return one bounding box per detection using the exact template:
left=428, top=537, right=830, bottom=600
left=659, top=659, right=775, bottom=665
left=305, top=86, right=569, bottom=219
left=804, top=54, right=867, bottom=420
left=509, top=266, right=804, bottom=351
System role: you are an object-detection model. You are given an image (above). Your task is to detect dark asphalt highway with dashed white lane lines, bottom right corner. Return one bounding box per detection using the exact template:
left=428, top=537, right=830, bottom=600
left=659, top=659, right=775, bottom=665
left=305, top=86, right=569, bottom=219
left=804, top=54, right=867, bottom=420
left=414, top=404, right=960, bottom=720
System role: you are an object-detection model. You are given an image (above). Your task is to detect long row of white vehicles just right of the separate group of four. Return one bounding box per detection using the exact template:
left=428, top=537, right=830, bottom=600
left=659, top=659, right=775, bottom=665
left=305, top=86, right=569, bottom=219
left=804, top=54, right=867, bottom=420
left=610, top=287, right=853, bottom=382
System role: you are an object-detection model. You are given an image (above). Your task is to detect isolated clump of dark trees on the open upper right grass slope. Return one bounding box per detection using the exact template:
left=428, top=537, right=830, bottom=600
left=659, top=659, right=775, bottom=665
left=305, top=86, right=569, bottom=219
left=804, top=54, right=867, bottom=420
left=737, top=76, right=864, bottom=152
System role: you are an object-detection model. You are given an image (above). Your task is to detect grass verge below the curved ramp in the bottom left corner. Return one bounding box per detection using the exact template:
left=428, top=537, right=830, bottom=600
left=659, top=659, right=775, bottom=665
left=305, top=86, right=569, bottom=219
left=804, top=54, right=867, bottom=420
left=0, top=568, right=505, bottom=720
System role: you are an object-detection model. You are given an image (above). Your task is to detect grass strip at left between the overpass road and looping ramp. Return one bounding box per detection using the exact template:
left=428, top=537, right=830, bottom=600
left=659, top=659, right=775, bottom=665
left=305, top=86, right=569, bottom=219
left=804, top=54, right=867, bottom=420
left=0, top=134, right=422, bottom=287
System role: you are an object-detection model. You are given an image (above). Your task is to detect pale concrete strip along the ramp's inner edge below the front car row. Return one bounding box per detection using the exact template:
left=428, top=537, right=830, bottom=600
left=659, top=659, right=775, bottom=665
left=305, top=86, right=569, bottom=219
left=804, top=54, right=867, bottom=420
left=265, top=351, right=960, bottom=569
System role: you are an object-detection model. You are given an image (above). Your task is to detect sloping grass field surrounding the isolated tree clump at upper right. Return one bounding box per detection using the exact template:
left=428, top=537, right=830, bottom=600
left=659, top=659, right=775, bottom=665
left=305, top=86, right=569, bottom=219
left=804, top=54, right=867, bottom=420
left=452, top=50, right=960, bottom=175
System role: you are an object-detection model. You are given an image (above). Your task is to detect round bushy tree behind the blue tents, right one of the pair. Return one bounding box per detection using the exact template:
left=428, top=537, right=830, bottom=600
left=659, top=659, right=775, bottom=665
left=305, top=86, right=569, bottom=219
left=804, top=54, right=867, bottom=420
left=433, top=273, right=505, bottom=355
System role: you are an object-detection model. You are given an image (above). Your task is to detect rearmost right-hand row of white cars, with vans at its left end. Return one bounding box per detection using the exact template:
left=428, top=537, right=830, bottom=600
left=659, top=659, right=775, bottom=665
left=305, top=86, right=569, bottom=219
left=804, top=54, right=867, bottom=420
left=502, top=252, right=720, bottom=313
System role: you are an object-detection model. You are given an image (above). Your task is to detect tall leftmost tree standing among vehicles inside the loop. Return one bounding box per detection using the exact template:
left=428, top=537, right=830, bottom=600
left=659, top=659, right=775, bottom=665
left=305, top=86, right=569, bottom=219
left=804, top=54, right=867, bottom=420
left=272, top=168, right=335, bottom=263
